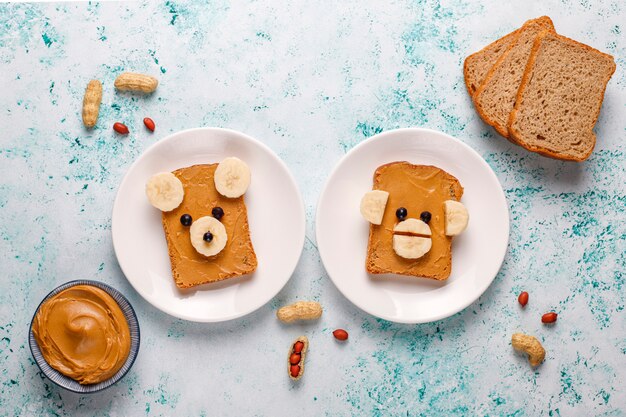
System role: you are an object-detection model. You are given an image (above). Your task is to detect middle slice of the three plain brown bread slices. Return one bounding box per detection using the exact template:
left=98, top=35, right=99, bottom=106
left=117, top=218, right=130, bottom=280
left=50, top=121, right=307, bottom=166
left=474, top=16, right=554, bottom=138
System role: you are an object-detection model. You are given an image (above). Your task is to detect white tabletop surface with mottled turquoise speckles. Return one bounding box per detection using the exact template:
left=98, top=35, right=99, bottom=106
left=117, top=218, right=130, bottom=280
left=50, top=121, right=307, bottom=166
left=0, top=0, right=626, bottom=416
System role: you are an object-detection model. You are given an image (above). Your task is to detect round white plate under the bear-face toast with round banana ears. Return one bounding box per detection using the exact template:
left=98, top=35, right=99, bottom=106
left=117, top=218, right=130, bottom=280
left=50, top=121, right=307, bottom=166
left=112, top=128, right=305, bottom=322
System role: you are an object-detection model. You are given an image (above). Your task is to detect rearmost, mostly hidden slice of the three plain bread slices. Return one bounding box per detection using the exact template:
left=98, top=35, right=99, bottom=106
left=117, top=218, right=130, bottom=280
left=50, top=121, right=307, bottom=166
left=463, top=29, right=519, bottom=97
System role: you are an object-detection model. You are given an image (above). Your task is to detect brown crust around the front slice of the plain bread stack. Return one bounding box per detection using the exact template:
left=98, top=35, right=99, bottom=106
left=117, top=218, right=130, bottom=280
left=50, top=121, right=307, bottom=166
left=507, top=30, right=616, bottom=162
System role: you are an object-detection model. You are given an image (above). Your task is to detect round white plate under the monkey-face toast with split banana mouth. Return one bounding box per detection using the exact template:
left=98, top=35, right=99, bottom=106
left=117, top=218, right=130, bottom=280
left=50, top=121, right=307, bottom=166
left=316, top=129, right=509, bottom=323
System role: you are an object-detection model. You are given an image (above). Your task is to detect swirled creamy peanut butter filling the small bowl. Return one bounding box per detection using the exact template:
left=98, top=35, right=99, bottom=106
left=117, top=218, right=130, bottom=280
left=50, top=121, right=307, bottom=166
left=32, top=285, right=130, bottom=384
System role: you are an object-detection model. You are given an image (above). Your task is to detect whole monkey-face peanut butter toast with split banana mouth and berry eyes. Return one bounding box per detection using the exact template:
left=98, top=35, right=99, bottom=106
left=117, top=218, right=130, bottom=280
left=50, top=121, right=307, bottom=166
left=362, top=162, right=469, bottom=280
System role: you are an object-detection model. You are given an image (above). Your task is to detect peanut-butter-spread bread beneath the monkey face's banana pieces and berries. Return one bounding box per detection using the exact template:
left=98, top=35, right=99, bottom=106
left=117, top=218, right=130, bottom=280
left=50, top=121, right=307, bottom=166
left=365, top=162, right=463, bottom=280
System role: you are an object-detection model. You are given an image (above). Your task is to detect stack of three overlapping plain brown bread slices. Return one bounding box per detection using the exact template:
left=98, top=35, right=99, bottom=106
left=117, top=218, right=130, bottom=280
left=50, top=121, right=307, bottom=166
left=464, top=16, right=615, bottom=161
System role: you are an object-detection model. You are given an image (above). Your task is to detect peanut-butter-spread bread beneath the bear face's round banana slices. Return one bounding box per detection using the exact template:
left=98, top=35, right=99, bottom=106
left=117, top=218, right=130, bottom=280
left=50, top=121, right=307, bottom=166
left=162, top=164, right=257, bottom=288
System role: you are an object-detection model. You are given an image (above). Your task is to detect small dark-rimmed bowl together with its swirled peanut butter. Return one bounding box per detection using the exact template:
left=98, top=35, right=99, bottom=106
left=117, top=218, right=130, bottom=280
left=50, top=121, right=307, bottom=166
left=29, top=280, right=140, bottom=394
